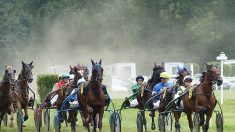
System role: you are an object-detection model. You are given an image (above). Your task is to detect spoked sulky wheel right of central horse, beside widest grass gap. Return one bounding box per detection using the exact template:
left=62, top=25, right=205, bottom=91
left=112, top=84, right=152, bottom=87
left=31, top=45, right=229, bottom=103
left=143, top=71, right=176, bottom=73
left=109, top=112, right=121, bottom=132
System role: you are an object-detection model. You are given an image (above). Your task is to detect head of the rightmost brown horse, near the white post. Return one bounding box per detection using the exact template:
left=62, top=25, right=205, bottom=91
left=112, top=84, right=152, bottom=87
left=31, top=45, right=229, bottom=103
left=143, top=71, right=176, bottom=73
left=206, top=63, right=223, bottom=86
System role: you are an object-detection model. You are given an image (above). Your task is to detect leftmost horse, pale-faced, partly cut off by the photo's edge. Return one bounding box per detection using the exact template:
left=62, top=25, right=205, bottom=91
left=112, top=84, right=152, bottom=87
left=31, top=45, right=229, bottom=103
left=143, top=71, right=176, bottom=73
left=0, top=66, right=16, bottom=127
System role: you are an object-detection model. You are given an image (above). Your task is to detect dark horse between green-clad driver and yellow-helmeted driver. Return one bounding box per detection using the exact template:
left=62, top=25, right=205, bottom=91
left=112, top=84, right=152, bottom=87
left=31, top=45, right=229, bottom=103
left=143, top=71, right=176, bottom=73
left=137, top=63, right=165, bottom=131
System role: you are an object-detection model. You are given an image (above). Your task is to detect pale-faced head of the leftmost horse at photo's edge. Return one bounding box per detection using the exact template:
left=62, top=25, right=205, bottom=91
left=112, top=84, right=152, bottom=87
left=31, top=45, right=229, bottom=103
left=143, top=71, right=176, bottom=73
left=3, top=66, right=16, bottom=83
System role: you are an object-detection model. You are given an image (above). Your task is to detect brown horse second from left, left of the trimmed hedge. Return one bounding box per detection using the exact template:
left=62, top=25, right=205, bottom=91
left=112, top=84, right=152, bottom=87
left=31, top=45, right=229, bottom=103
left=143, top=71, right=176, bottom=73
left=15, top=61, right=34, bottom=121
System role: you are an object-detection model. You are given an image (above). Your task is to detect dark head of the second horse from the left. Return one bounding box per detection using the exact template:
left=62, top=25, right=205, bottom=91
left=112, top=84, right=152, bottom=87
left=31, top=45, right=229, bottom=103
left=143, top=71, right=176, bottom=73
left=21, top=61, right=34, bottom=83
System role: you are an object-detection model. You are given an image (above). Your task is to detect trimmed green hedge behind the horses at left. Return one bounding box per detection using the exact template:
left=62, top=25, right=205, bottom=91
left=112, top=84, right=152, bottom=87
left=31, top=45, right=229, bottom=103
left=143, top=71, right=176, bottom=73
left=37, top=74, right=58, bottom=101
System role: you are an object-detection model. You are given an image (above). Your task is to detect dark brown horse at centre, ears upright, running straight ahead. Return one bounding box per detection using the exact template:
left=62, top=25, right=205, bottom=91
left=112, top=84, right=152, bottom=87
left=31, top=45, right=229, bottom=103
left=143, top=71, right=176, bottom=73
left=83, top=59, right=105, bottom=132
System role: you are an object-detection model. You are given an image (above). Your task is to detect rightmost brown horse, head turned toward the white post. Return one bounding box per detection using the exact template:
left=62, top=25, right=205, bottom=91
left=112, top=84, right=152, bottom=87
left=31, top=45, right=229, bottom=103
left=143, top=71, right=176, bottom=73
left=183, top=64, right=223, bottom=132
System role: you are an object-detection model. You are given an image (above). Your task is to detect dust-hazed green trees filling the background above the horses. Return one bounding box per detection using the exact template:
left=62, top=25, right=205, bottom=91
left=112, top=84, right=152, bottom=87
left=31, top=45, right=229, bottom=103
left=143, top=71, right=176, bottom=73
left=0, top=0, right=235, bottom=66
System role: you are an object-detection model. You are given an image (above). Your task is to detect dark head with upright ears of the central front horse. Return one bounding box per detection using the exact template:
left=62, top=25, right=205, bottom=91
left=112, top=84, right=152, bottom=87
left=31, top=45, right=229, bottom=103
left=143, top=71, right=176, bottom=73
left=91, top=59, right=103, bottom=83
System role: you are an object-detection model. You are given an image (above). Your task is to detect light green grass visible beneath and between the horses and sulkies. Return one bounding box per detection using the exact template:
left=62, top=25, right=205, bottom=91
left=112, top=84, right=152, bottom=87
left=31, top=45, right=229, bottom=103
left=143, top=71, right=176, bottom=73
left=0, top=90, right=235, bottom=132
